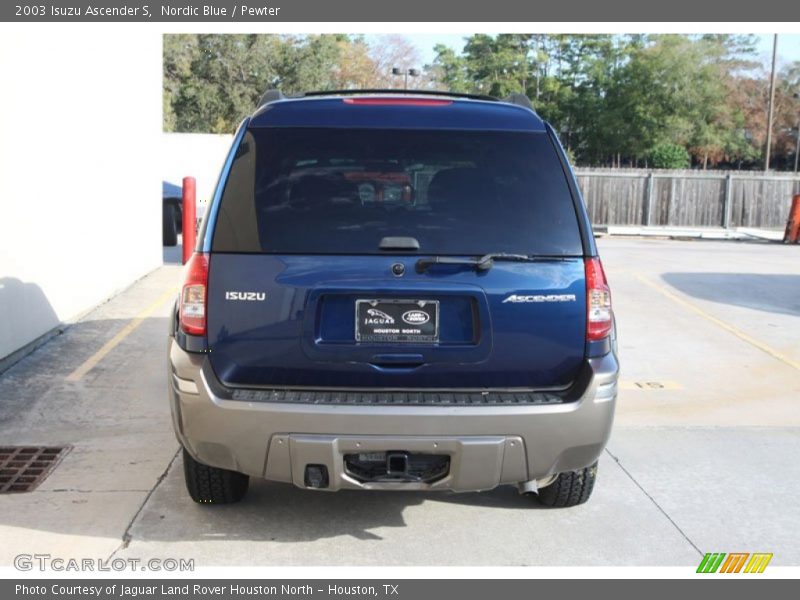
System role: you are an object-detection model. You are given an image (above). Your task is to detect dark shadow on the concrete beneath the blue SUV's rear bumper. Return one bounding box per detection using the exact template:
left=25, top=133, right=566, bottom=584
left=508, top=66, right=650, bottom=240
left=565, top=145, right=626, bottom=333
left=120, top=459, right=538, bottom=543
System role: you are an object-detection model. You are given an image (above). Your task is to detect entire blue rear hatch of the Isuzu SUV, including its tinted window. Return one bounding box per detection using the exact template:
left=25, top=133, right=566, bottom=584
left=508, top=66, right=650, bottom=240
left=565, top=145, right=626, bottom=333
left=208, top=115, right=586, bottom=390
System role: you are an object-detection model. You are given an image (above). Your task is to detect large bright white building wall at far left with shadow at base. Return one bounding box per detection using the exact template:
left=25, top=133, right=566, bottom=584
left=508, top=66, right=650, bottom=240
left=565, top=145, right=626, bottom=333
left=0, top=23, right=162, bottom=359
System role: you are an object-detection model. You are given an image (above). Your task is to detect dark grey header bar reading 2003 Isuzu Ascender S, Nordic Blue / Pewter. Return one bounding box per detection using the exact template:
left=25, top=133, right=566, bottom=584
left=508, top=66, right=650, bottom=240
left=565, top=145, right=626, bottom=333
left=0, top=0, right=800, bottom=23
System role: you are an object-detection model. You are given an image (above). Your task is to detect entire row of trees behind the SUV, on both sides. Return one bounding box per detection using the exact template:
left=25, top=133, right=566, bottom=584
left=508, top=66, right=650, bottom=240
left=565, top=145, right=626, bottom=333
left=163, top=33, right=800, bottom=168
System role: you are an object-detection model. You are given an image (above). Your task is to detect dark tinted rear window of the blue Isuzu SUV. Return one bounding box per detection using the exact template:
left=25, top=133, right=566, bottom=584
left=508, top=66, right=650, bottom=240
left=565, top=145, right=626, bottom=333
left=212, top=128, right=582, bottom=256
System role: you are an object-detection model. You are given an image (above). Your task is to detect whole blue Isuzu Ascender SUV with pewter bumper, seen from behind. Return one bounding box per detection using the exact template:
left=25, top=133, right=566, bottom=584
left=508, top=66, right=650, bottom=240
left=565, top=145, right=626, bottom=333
left=168, top=90, right=619, bottom=507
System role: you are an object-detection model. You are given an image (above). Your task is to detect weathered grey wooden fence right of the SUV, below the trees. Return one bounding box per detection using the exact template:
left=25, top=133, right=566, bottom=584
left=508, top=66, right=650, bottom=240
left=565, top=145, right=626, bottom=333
left=575, top=169, right=800, bottom=228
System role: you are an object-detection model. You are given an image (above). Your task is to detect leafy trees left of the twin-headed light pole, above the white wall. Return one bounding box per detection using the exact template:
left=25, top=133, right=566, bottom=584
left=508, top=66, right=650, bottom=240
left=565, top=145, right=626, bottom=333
left=163, top=34, right=444, bottom=133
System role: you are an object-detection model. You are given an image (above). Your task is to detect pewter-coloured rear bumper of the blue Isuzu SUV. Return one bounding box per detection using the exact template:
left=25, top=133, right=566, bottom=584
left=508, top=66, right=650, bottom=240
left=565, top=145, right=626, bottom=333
left=169, top=338, right=619, bottom=491
